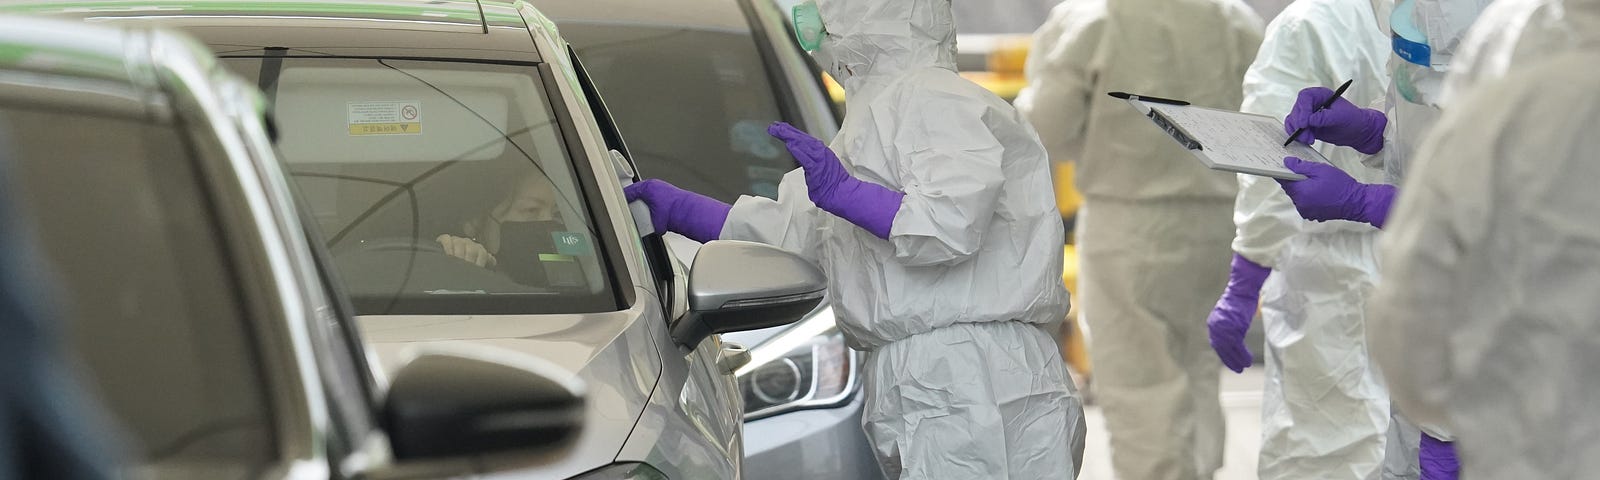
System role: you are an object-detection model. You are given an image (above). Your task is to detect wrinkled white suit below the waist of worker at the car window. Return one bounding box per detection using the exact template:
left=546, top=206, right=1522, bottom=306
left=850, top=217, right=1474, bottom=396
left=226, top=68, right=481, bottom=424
left=862, top=322, right=1085, bottom=480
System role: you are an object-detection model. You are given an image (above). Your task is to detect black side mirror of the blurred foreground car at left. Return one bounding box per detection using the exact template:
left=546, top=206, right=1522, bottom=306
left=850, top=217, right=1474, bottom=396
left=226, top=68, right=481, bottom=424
left=382, top=347, right=584, bottom=461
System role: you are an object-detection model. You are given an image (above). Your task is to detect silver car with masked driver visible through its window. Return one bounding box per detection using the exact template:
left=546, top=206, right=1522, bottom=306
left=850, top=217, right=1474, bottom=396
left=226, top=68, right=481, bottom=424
left=12, top=0, right=824, bottom=478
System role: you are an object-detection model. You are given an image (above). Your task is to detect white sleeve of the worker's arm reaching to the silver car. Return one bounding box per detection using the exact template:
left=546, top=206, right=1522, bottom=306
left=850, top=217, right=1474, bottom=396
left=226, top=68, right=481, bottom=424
left=722, top=168, right=827, bottom=262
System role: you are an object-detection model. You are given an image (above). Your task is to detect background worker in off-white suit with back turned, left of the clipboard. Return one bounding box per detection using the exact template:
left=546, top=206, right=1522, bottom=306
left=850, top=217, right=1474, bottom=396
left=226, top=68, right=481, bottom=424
left=1016, top=0, right=1261, bottom=480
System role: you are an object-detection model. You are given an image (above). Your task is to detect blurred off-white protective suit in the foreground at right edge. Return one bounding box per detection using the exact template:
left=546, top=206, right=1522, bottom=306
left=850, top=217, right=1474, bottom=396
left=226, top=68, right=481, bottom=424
left=1371, top=0, right=1600, bottom=478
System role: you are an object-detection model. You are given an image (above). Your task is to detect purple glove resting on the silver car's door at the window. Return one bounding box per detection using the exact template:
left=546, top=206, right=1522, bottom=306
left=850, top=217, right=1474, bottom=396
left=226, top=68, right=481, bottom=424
left=622, top=179, right=733, bottom=243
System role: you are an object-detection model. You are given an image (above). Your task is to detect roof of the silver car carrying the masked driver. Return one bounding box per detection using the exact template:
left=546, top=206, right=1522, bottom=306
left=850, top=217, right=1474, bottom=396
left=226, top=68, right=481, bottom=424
left=0, top=0, right=542, bottom=62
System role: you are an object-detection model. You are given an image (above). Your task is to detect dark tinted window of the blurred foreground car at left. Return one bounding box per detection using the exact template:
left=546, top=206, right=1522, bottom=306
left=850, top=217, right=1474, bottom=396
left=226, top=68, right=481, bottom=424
left=0, top=107, right=275, bottom=478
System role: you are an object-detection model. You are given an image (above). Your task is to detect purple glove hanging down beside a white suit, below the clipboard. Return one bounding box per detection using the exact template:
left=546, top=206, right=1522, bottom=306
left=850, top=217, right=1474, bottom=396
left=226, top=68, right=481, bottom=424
left=1205, top=253, right=1272, bottom=373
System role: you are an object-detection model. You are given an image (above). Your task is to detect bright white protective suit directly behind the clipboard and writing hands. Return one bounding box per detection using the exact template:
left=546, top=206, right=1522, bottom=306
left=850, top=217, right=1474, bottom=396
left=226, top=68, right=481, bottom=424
left=1234, top=0, right=1421, bottom=480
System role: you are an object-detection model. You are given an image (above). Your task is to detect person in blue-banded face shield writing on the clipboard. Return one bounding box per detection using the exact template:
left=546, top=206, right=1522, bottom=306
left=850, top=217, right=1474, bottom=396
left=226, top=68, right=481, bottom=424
left=1278, top=0, right=1490, bottom=480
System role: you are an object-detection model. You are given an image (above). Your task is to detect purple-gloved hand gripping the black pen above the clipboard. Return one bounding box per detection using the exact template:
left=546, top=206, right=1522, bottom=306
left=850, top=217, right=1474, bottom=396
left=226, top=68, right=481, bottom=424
left=1283, top=86, right=1389, bottom=155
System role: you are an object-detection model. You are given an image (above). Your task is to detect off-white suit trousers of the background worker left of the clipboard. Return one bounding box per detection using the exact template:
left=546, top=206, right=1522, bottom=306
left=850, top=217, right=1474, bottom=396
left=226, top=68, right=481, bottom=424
left=1077, top=200, right=1234, bottom=478
